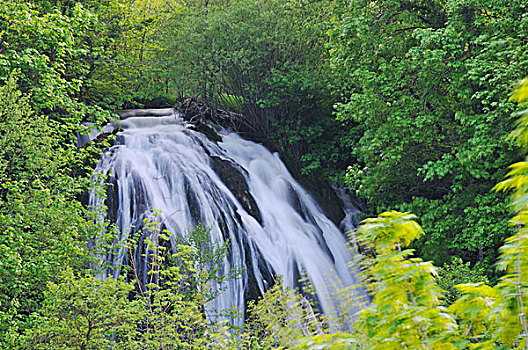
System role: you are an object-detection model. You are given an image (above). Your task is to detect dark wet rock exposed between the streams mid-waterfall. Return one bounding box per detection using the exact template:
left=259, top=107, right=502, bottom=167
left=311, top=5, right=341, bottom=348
left=211, top=156, right=262, bottom=224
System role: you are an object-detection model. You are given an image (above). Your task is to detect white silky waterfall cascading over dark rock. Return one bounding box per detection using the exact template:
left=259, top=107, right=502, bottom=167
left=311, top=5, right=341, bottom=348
left=91, top=108, right=364, bottom=322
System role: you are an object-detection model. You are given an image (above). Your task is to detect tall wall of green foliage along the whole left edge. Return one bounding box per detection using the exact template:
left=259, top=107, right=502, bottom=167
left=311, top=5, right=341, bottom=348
left=0, top=0, right=121, bottom=342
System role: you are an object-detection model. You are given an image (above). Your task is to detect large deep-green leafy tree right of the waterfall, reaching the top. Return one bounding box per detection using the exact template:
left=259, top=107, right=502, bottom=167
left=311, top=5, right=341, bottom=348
left=329, top=0, right=528, bottom=275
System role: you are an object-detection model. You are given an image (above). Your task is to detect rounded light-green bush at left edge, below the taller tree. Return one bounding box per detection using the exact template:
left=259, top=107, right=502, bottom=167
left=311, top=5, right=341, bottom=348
left=0, top=72, right=92, bottom=349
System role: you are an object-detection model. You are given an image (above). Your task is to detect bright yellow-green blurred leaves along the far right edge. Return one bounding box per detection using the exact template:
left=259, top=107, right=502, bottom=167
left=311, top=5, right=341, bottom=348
left=472, top=79, right=528, bottom=348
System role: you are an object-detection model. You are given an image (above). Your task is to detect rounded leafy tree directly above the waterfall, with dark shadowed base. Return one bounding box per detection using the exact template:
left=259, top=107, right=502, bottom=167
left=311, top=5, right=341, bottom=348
left=160, top=0, right=348, bottom=177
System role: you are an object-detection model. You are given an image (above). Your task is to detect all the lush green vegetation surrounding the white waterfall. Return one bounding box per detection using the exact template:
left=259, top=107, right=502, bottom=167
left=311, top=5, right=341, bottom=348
left=0, top=0, right=528, bottom=349
